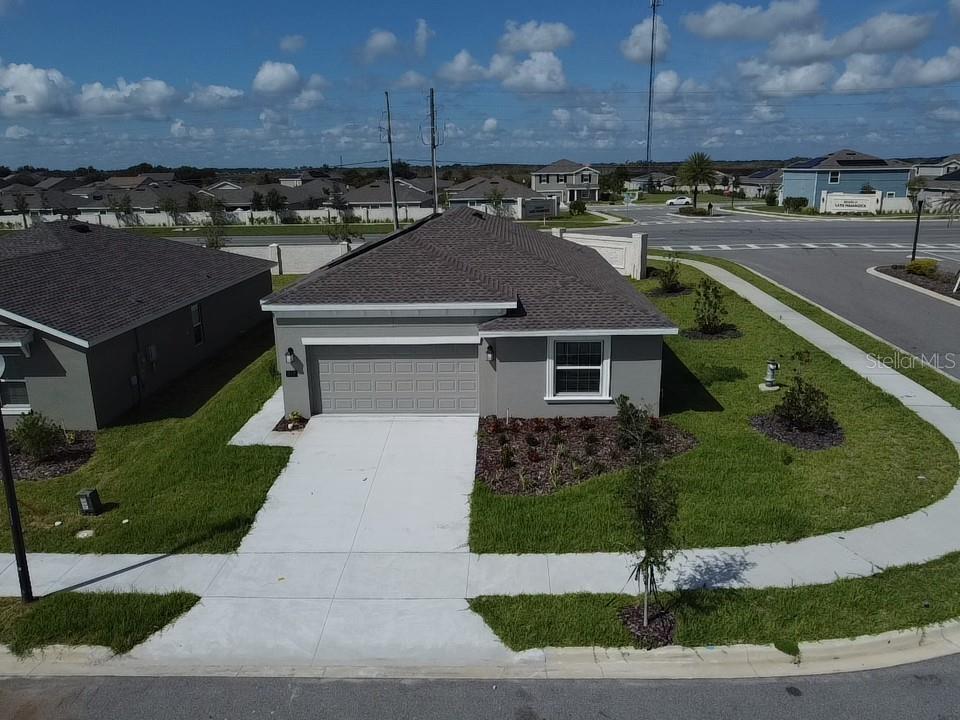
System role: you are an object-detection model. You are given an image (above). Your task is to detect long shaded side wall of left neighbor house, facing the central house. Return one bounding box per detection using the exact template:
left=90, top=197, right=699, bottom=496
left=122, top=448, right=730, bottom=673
left=87, top=271, right=272, bottom=427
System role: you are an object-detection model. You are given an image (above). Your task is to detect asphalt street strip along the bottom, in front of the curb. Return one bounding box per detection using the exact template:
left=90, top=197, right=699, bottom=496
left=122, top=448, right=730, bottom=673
left=0, top=656, right=960, bottom=720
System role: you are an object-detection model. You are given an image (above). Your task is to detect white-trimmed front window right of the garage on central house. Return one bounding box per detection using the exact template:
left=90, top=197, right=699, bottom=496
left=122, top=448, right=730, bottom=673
left=547, top=337, right=610, bottom=400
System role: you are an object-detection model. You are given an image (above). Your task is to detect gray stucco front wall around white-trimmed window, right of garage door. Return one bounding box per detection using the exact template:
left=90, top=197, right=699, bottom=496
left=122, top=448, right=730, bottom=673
left=480, top=335, right=663, bottom=417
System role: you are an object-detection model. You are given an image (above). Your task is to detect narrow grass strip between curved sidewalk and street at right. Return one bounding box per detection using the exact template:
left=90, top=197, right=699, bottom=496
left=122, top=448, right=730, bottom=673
left=676, top=253, right=960, bottom=408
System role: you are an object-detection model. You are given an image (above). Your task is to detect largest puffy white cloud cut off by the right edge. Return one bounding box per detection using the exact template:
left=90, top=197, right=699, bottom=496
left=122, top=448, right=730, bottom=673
left=833, top=47, right=960, bottom=93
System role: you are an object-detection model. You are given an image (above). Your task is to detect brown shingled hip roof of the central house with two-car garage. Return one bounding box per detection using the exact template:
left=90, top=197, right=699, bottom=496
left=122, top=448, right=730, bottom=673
left=263, top=207, right=675, bottom=334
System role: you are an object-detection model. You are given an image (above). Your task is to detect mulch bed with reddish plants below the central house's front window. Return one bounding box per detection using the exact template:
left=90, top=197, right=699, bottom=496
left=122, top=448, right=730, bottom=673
left=477, top=416, right=697, bottom=495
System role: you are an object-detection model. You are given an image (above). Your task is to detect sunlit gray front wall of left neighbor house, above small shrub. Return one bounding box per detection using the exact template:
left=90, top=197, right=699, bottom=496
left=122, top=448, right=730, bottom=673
left=11, top=331, right=97, bottom=430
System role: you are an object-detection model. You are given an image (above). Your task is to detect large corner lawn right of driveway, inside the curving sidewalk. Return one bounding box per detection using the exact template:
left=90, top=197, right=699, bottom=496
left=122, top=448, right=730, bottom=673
left=470, top=268, right=958, bottom=553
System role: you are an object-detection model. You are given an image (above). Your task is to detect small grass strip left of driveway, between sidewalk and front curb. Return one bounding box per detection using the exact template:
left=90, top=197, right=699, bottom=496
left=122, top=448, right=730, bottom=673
left=0, top=593, right=200, bottom=655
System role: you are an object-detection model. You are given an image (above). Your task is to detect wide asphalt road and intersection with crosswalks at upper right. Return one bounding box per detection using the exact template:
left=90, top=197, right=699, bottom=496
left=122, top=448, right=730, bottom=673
left=588, top=206, right=960, bottom=379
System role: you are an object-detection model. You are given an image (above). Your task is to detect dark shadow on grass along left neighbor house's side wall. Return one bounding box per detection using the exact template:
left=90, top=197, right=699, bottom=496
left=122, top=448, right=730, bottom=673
left=114, top=322, right=273, bottom=425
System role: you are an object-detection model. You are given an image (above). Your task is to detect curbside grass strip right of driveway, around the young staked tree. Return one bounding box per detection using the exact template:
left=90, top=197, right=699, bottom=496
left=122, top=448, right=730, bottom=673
left=470, top=553, right=960, bottom=651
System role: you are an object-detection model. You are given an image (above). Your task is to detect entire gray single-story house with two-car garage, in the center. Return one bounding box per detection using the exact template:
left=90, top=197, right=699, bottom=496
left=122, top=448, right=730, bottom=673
left=262, top=207, right=677, bottom=417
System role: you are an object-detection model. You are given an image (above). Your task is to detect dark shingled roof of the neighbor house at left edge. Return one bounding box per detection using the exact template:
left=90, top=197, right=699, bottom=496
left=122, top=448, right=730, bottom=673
left=0, top=221, right=273, bottom=346
